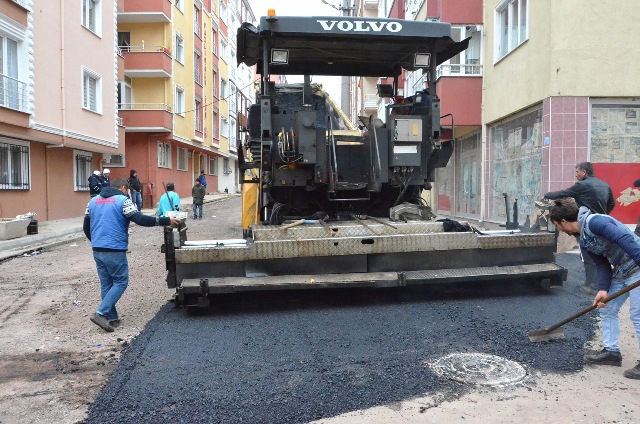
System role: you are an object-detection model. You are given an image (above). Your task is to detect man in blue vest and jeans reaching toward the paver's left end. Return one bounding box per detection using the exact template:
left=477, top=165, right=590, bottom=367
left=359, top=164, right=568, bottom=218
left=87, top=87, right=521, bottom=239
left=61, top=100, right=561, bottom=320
left=82, top=178, right=180, bottom=332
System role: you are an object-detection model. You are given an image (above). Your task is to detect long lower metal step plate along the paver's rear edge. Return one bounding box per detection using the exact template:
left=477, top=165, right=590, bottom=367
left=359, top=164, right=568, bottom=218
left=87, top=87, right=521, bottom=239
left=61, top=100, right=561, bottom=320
left=178, top=264, right=566, bottom=295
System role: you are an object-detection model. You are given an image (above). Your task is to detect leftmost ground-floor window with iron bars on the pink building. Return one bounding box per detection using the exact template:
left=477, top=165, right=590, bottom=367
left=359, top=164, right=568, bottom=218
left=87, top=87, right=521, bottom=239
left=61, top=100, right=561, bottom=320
left=0, top=140, right=29, bottom=190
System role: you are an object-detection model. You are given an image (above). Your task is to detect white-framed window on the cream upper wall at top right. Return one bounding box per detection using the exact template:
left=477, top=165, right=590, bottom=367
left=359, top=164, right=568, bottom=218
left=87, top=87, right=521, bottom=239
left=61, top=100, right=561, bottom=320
left=494, top=0, right=529, bottom=60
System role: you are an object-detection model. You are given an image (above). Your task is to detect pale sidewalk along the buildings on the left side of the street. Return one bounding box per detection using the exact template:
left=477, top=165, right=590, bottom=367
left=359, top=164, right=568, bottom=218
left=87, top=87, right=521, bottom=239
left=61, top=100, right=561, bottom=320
left=0, top=193, right=236, bottom=261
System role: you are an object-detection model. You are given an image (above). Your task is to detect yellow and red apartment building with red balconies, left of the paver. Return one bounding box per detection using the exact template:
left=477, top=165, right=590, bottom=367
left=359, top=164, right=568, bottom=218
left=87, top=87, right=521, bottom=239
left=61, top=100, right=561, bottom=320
left=116, top=0, right=253, bottom=206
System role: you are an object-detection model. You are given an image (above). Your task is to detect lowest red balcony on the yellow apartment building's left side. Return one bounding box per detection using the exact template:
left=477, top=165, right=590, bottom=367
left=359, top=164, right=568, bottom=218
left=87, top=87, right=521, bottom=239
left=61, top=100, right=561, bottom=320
left=118, top=103, right=173, bottom=133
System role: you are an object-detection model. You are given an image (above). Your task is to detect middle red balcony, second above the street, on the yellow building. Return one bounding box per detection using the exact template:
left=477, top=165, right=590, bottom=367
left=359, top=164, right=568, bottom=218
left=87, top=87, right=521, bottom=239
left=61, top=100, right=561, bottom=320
left=120, top=45, right=171, bottom=78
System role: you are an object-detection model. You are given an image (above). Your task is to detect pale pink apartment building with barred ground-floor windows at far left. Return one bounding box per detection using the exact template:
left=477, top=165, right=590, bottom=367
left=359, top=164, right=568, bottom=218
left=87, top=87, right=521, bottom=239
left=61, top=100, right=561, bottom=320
left=0, top=0, right=124, bottom=220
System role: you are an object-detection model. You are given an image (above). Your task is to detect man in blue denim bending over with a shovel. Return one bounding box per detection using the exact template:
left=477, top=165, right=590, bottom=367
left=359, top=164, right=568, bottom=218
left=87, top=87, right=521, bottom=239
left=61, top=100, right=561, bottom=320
left=549, top=198, right=640, bottom=379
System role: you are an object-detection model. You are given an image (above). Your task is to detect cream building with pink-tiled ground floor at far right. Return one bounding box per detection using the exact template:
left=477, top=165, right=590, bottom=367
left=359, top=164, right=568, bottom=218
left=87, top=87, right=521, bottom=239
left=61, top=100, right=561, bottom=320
left=483, top=0, right=640, bottom=224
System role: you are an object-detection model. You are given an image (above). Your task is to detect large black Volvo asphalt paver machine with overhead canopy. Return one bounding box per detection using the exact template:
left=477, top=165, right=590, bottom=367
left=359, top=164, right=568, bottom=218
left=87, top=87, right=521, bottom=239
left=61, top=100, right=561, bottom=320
left=163, top=12, right=566, bottom=306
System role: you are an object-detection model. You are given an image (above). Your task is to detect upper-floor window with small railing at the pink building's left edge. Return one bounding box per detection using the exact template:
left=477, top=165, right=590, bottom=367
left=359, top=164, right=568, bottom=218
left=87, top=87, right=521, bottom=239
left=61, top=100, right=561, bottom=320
left=0, top=36, right=26, bottom=110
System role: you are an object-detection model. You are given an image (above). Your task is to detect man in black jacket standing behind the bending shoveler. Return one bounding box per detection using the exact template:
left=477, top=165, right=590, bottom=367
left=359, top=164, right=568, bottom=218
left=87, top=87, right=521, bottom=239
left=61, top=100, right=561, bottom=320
left=544, top=162, right=616, bottom=295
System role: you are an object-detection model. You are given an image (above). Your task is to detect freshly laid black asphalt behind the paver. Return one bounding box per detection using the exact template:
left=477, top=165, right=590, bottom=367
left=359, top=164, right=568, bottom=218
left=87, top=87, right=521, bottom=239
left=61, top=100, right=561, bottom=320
left=87, top=245, right=596, bottom=423
